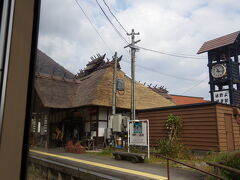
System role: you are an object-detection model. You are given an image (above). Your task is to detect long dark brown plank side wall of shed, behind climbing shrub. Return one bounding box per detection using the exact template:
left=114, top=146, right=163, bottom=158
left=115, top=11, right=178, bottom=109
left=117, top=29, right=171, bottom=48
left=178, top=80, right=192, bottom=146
left=138, top=104, right=221, bottom=151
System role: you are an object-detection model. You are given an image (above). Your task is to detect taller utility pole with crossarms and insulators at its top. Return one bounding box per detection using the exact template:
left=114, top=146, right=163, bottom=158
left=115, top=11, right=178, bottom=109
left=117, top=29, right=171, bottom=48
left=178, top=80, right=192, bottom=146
left=124, top=29, right=140, bottom=120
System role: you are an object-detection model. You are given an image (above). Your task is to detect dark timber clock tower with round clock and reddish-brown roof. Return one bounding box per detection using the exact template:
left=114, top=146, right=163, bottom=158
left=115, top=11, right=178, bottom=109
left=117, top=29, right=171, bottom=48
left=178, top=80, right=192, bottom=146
left=198, top=31, right=240, bottom=106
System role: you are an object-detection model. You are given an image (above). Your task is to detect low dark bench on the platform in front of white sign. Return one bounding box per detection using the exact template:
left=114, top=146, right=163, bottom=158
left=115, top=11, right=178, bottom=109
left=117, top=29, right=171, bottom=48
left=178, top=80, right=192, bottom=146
left=112, top=152, right=146, bottom=163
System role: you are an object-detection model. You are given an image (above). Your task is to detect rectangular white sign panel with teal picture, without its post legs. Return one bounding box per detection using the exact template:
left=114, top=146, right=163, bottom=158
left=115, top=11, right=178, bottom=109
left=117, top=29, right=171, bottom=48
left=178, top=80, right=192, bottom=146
left=129, top=121, right=148, bottom=146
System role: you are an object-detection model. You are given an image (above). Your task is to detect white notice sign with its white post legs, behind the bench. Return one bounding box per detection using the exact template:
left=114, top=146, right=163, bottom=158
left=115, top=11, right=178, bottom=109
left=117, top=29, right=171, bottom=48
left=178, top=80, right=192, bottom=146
left=128, top=120, right=150, bottom=158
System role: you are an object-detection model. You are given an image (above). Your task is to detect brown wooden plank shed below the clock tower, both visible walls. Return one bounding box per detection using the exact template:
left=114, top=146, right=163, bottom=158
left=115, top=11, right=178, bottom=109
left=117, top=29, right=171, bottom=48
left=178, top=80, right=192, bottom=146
left=138, top=102, right=240, bottom=151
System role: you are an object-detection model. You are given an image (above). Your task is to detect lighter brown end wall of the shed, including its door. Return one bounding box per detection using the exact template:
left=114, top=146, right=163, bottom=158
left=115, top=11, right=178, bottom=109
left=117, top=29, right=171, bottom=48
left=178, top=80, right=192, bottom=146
left=216, top=105, right=240, bottom=151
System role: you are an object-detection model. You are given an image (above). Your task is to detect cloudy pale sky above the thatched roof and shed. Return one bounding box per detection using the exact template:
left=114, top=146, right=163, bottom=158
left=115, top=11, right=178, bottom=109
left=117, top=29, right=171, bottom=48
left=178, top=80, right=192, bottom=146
left=38, top=0, right=240, bottom=99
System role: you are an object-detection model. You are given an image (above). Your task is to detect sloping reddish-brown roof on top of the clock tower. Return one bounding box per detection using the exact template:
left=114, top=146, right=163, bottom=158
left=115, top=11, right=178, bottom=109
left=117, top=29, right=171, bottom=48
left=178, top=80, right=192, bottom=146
left=197, top=31, right=240, bottom=54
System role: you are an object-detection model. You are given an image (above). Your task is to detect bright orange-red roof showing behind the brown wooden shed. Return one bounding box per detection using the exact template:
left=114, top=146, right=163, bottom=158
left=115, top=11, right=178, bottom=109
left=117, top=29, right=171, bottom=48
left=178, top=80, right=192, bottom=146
left=171, top=95, right=208, bottom=105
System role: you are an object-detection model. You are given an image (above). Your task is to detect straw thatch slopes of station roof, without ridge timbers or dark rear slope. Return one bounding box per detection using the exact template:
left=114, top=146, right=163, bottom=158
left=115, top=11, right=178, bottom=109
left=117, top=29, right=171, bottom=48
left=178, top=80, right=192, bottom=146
left=35, top=65, right=174, bottom=109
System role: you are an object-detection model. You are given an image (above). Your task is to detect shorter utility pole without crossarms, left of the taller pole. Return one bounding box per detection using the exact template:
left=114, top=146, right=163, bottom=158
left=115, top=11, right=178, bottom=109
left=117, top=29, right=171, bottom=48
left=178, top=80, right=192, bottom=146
left=112, top=52, right=118, bottom=115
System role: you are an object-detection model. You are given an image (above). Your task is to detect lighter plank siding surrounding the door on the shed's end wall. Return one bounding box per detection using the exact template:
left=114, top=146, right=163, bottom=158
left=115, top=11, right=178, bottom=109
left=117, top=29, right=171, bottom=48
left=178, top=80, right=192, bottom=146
left=216, top=105, right=240, bottom=151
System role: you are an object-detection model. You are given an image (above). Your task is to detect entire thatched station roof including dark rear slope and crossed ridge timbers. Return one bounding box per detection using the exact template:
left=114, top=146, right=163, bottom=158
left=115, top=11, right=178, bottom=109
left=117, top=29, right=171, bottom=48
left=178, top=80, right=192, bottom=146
left=35, top=50, right=175, bottom=109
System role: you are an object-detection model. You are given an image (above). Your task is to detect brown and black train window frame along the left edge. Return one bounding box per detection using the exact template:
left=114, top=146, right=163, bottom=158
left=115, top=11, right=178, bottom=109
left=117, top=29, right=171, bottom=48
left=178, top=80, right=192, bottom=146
left=0, top=0, right=41, bottom=179
